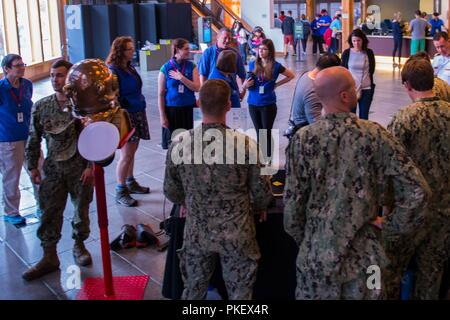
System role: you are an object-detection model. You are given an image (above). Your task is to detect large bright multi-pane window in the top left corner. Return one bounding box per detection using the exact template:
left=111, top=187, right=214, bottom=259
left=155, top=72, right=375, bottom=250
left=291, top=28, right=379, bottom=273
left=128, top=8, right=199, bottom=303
left=0, top=0, right=61, bottom=64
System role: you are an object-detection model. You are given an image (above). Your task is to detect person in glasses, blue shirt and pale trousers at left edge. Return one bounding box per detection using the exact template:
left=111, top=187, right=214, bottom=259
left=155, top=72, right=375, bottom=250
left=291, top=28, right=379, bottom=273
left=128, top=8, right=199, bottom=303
left=0, top=54, right=33, bottom=225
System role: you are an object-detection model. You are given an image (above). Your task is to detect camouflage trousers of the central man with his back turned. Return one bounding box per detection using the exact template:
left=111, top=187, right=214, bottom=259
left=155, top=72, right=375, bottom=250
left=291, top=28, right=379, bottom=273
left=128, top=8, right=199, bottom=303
left=178, top=246, right=258, bottom=300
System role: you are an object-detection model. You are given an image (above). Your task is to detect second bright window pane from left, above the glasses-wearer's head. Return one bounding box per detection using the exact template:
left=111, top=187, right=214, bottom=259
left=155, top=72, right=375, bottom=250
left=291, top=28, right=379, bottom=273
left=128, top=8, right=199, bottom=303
left=16, top=0, right=33, bottom=63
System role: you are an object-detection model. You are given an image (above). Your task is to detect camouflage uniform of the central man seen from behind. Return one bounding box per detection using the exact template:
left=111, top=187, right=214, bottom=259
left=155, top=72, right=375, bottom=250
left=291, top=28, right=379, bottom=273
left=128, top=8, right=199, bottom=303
left=164, top=124, right=271, bottom=300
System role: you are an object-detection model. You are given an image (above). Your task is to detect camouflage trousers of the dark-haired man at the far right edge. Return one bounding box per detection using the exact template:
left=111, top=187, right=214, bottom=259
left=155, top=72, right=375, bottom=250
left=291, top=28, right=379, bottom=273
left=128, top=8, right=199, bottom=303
left=414, top=215, right=450, bottom=300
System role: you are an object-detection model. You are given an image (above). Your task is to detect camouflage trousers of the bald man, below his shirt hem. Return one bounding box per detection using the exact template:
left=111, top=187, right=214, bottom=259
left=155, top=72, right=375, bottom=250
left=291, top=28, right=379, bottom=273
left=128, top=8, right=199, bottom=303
left=295, top=269, right=383, bottom=300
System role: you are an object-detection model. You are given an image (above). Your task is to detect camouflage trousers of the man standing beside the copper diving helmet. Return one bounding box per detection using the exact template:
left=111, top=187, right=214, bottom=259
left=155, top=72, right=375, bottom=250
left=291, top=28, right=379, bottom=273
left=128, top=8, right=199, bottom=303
left=37, top=154, right=93, bottom=247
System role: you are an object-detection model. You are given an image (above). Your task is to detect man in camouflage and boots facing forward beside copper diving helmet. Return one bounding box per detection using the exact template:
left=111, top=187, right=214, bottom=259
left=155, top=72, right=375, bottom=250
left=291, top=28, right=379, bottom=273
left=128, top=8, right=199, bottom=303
left=23, top=60, right=93, bottom=280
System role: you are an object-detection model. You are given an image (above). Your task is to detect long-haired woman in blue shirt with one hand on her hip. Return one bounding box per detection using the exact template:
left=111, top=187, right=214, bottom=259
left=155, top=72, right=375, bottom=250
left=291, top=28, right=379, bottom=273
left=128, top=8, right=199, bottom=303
left=243, top=39, right=295, bottom=157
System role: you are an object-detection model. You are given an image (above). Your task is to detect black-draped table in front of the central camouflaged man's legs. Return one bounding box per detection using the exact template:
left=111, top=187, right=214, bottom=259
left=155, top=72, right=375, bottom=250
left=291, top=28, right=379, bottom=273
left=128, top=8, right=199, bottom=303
left=162, top=198, right=298, bottom=300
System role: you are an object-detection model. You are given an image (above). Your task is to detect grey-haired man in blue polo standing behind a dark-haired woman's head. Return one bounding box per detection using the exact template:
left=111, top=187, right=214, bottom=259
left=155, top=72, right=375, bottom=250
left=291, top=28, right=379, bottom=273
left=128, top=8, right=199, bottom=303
left=198, top=28, right=245, bottom=85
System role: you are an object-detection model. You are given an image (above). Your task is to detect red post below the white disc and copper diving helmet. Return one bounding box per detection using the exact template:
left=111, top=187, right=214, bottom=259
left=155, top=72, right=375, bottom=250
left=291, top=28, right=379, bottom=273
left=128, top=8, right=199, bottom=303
left=94, top=163, right=114, bottom=297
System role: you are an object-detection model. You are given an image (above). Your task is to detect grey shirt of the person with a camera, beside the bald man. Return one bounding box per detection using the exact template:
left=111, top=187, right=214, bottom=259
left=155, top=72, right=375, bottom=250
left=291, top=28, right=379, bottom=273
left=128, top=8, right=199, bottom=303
left=292, top=72, right=322, bottom=124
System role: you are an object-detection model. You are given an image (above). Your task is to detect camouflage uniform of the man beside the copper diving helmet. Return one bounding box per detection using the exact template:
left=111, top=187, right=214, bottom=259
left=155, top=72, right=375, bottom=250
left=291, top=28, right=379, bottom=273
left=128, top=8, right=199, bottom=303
left=26, top=95, right=93, bottom=247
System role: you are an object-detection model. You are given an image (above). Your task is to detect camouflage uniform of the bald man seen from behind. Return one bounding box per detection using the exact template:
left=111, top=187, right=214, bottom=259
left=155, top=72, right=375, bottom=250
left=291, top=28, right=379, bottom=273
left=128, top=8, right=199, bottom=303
left=284, top=113, right=429, bottom=299
